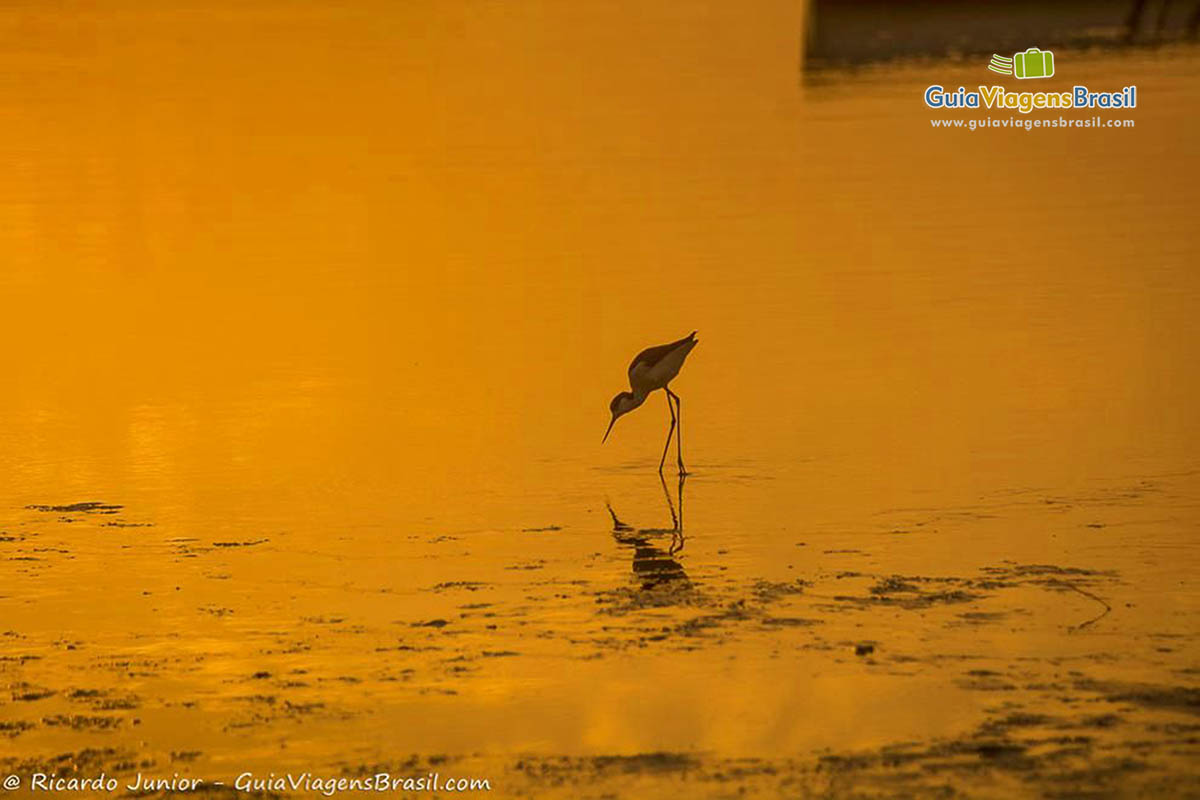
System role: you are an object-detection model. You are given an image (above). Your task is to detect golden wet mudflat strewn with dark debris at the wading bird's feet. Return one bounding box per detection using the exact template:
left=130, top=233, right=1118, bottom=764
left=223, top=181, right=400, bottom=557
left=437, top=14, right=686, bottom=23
left=0, top=469, right=1200, bottom=796
